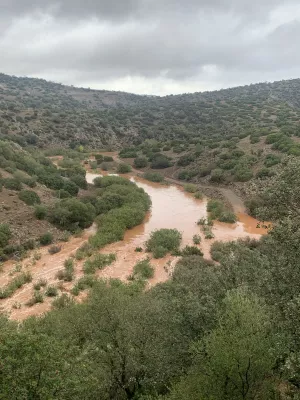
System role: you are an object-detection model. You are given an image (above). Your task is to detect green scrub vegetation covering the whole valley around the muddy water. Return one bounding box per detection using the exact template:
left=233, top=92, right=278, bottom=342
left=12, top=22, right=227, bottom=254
left=0, top=74, right=300, bottom=400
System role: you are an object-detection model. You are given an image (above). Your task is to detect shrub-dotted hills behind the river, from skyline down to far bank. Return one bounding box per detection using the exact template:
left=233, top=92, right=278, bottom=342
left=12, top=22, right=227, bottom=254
left=0, top=74, right=300, bottom=190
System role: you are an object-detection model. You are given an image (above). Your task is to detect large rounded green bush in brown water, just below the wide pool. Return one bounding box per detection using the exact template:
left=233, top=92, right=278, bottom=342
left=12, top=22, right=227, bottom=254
left=146, top=229, right=182, bottom=258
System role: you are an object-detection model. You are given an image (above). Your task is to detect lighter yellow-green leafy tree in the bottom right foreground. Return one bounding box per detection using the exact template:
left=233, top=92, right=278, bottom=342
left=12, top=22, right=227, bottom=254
left=171, top=289, right=276, bottom=400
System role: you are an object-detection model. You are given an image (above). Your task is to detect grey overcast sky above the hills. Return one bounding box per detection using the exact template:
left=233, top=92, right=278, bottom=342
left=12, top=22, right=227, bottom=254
left=0, top=0, right=300, bottom=95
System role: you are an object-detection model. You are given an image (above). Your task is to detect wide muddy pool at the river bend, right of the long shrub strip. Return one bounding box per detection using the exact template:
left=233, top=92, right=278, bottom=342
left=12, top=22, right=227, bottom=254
left=87, top=173, right=267, bottom=285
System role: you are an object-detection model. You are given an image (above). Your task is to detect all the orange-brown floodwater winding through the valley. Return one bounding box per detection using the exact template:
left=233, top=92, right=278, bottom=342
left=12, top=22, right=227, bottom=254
left=0, top=172, right=267, bottom=320
